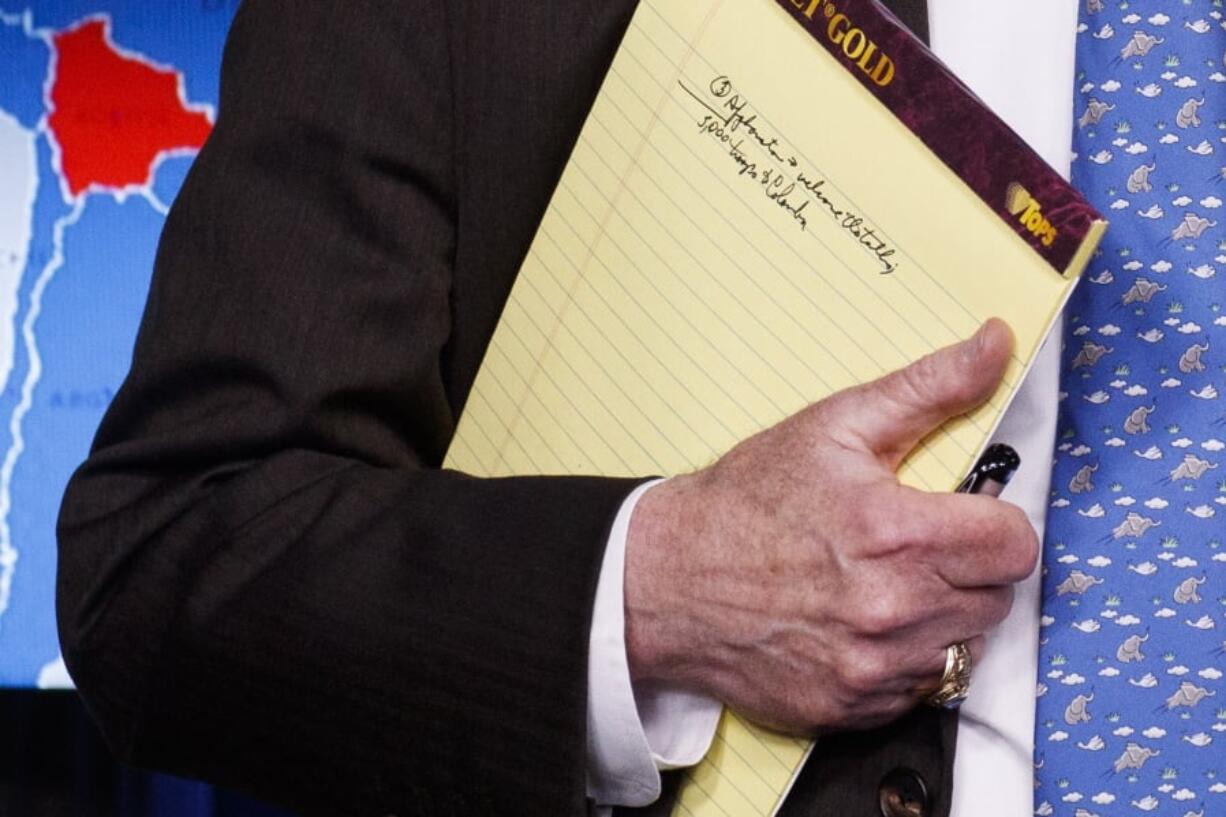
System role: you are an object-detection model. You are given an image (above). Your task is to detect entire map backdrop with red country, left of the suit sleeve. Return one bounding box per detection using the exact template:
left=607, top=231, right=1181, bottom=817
left=0, top=0, right=238, bottom=687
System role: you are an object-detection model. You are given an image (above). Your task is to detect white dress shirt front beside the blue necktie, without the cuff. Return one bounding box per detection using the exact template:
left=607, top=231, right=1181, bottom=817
left=928, top=7, right=1078, bottom=817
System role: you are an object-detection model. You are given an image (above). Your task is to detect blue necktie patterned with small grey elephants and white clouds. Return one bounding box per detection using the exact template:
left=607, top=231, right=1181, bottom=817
left=1035, top=6, right=1226, bottom=817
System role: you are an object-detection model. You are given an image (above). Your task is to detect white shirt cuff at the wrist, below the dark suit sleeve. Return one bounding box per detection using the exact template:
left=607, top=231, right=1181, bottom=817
left=587, top=480, right=723, bottom=806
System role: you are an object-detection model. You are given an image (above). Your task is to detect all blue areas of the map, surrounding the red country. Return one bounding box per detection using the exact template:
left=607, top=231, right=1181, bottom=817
left=0, top=0, right=238, bottom=687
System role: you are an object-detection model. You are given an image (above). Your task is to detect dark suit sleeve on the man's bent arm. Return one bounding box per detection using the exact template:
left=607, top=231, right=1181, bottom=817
left=58, top=0, right=631, bottom=815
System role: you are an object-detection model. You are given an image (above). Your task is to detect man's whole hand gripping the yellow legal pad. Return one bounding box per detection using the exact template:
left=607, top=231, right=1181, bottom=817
left=625, top=320, right=1038, bottom=732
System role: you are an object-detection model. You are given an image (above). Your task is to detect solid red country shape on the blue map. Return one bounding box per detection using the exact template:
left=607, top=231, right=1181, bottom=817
left=49, top=20, right=212, bottom=195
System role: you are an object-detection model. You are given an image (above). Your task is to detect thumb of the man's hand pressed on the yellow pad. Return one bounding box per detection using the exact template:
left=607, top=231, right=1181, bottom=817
left=823, top=318, right=1013, bottom=470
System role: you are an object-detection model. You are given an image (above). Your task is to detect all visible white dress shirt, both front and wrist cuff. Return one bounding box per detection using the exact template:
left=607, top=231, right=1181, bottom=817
left=587, top=0, right=1078, bottom=817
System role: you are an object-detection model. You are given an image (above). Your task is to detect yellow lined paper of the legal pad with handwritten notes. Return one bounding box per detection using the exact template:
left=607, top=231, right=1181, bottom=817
left=446, top=0, right=1102, bottom=817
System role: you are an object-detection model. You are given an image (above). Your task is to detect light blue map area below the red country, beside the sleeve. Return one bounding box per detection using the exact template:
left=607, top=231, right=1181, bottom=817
left=0, top=192, right=163, bottom=682
